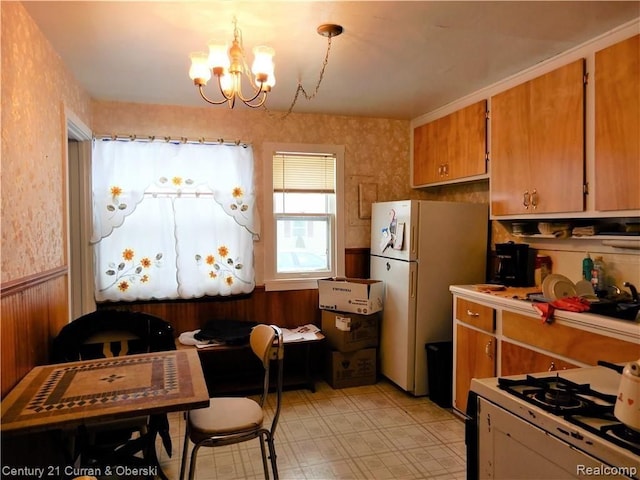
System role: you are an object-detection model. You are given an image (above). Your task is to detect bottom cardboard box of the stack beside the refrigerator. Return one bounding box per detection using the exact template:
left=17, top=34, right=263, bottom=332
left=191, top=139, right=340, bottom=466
left=327, top=348, right=377, bottom=388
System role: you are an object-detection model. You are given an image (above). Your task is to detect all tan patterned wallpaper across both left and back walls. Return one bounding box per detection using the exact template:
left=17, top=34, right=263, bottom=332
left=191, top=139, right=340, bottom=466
left=1, top=2, right=488, bottom=282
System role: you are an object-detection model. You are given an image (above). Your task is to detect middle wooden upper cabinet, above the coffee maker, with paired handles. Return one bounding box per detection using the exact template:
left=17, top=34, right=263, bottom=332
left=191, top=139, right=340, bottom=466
left=489, top=59, right=585, bottom=215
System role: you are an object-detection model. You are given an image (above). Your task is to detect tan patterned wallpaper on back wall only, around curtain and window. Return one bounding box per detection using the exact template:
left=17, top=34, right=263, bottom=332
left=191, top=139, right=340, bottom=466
left=93, top=101, right=488, bottom=282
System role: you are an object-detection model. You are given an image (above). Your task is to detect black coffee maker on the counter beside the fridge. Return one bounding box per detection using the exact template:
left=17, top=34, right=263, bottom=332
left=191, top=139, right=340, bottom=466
left=495, top=242, right=536, bottom=287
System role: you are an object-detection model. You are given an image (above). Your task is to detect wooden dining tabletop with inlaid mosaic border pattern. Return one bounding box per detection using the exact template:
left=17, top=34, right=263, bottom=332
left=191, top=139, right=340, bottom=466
left=0, top=350, right=209, bottom=477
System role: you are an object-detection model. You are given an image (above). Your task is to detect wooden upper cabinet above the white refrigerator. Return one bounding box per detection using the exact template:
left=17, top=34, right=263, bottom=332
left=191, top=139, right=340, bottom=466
left=413, top=100, right=487, bottom=186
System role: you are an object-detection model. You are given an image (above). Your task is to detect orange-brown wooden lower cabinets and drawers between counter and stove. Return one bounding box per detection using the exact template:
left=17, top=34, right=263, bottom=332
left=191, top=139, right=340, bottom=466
left=452, top=287, right=640, bottom=413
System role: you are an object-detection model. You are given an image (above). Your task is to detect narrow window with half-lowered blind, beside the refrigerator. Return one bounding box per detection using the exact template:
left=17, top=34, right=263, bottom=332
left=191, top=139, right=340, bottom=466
left=264, top=144, right=344, bottom=290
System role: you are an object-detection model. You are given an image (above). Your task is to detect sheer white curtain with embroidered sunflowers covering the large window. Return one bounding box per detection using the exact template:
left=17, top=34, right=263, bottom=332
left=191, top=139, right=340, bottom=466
left=92, top=140, right=259, bottom=301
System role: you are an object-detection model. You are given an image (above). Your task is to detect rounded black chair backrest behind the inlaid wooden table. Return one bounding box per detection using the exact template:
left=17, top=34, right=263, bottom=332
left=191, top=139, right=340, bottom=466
left=51, top=310, right=175, bottom=363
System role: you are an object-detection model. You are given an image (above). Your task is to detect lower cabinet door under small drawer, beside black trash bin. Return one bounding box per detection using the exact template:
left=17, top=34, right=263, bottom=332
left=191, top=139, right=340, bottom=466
left=453, top=324, right=496, bottom=412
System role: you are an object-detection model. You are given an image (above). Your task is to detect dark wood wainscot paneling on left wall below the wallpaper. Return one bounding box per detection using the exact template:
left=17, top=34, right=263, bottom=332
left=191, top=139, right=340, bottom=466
left=0, top=266, right=69, bottom=397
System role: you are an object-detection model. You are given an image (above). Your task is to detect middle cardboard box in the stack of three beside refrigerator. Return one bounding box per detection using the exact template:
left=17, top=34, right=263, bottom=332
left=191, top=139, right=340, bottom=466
left=321, top=310, right=380, bottom=352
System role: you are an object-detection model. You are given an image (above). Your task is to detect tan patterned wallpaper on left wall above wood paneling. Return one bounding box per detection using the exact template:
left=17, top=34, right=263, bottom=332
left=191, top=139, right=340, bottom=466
left=0, top=2, right=91, bottom=283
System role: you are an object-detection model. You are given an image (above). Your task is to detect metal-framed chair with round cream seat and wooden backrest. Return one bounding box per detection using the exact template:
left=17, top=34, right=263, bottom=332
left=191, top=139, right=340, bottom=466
left=180, top=324, right=284, bottom=480
